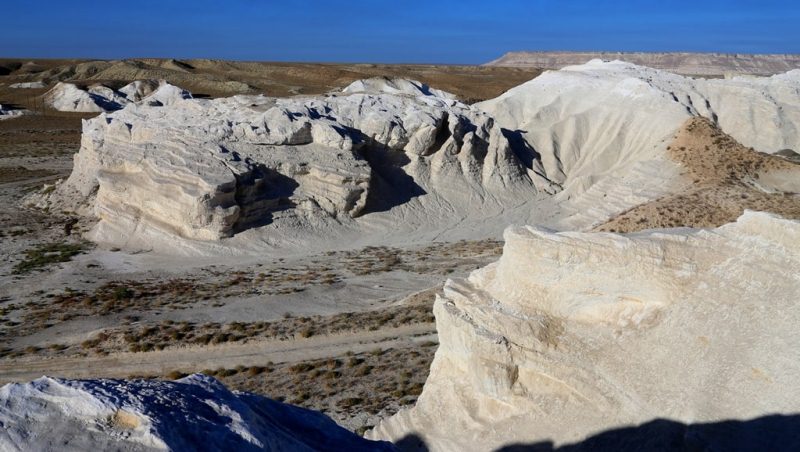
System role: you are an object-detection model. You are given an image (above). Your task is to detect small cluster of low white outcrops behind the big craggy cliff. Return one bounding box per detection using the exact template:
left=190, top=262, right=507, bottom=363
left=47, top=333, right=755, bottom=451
left=45, top=80, right=192, bottom=113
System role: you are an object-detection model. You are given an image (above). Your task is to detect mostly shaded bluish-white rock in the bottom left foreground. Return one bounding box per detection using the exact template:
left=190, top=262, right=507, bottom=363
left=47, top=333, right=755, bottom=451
left=0, top=374, right=394, bottom=452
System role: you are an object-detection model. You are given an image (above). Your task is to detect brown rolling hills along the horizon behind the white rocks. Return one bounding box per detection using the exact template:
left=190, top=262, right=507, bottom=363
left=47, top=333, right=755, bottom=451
left=0, top=59, right=541, bottom=104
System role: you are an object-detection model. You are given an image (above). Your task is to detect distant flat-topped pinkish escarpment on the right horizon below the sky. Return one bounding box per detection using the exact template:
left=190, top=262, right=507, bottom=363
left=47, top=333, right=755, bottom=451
left=487, top=52, right=800, bottom=76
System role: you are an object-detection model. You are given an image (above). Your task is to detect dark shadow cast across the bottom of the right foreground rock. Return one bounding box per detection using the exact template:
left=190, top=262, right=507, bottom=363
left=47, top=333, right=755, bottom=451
left=395, top=414, right=800, bottom=452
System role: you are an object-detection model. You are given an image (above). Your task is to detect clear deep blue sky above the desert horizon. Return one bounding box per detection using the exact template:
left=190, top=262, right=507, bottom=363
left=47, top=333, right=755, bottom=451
left=0, top=0, right=800, bottom=64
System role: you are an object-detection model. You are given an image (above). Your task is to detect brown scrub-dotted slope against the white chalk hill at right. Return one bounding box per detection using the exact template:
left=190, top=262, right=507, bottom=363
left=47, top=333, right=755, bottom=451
left=596, top=117, right=800, bottom=232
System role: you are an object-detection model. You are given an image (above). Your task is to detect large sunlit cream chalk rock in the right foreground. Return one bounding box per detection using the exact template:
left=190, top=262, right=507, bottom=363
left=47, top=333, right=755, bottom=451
left=370, top=212, right=800, bottom=451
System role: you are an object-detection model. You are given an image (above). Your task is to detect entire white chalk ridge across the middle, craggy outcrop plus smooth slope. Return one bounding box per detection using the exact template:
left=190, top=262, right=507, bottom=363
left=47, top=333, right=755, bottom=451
left=36, top=60, right=800, bottom=252
